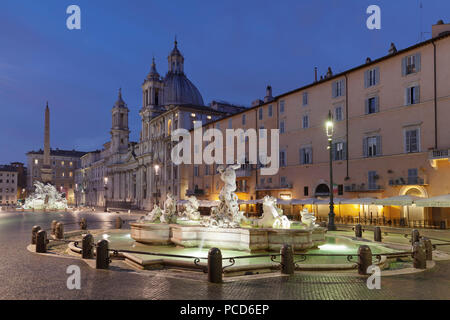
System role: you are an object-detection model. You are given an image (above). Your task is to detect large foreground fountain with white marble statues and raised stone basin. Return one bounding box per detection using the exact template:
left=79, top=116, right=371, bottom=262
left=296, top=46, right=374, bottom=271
left=130, top=164, right=326, bottom=252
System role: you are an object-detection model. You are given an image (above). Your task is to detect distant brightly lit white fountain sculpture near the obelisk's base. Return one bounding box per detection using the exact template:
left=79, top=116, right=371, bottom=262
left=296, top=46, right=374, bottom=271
left=22, top=181, right=68, bottom=210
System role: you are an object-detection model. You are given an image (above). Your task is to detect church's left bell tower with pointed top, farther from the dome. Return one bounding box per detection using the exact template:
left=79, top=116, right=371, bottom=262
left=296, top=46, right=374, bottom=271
left=110, top=89, right=130, bottom=153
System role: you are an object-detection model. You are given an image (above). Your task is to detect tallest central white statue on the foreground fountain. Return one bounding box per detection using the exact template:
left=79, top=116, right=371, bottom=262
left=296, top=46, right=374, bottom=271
left=204, top=164, right=246, bottom=228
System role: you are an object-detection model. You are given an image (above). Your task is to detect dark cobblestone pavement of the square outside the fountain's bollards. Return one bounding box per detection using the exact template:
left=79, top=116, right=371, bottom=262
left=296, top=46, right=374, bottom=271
left=0, top=213, right=450, bottom=300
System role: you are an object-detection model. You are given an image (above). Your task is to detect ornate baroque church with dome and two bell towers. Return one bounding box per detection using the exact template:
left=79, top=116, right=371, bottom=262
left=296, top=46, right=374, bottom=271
left=75, top=41, right=245, bottom=209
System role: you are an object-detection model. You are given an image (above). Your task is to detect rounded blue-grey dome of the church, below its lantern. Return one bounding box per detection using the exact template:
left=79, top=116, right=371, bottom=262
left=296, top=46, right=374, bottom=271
left=164, top=72, right=204, bottom=106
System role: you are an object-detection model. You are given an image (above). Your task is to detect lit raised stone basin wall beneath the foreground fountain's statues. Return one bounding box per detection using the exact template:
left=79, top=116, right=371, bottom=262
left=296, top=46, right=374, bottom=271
left=130, top=222, right=326, bottom=252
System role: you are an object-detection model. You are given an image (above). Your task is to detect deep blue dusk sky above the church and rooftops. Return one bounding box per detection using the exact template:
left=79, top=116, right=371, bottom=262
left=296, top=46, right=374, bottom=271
left=0, top=0, right=450, bottom=164
